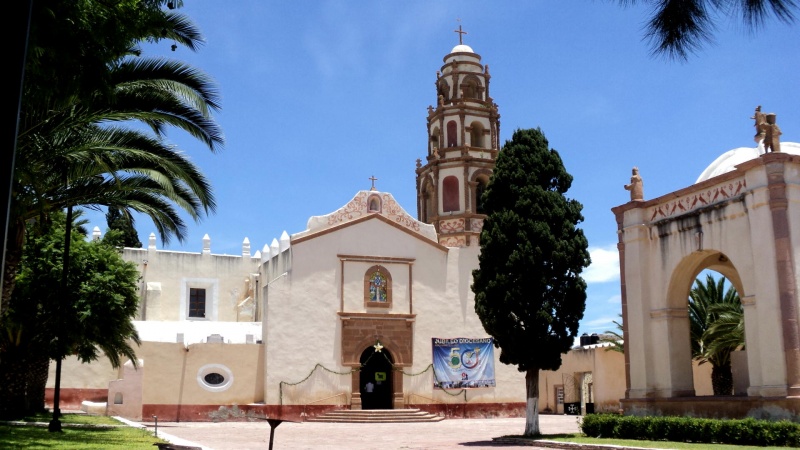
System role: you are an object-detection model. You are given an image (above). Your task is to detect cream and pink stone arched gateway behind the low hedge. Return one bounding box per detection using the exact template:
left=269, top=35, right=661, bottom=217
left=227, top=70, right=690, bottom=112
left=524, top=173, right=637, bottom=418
left=613, top=143, right=800, bottom=417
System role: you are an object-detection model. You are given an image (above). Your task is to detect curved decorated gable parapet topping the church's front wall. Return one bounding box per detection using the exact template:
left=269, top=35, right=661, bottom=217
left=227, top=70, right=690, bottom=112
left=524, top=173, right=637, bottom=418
left=292, top=191, right=438, bottom=243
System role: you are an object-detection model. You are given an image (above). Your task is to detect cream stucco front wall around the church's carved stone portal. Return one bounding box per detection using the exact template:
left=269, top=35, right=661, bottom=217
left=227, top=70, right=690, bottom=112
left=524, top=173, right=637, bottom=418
left=263, top=219, right=525, bottom=410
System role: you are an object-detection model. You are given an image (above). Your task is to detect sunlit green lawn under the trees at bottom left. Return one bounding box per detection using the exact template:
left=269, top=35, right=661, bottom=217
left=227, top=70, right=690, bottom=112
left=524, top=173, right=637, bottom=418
left=0, top=414, right=165, bottom=450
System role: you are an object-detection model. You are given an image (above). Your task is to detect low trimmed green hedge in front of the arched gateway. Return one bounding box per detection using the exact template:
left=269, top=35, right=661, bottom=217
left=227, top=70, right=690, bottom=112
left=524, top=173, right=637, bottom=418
left=580, top=414, right=800, bottom=447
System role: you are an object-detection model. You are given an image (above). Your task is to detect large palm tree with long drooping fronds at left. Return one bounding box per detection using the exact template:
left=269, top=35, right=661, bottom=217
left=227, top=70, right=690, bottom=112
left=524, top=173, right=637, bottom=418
left=0, top=5, right=223, bottom=418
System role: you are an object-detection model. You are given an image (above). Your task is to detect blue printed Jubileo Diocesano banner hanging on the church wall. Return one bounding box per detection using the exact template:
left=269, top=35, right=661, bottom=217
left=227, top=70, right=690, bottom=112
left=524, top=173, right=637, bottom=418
left=433, top=338, right=495, bottom=389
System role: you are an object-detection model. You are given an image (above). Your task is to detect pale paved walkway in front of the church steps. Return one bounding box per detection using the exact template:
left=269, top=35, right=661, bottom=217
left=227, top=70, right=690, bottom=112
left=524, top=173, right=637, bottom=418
left=143, top=415, right=578, bottom=450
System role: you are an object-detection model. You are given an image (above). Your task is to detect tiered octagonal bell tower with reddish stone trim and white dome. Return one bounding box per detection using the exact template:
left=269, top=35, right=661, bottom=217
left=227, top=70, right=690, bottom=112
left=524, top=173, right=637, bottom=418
left=416, top=29, right=500, bottom=247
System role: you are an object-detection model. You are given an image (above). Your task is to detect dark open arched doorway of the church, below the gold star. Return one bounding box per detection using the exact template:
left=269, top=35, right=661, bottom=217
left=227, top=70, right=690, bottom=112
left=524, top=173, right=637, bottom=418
left=358, top=346, right=394, bottom=409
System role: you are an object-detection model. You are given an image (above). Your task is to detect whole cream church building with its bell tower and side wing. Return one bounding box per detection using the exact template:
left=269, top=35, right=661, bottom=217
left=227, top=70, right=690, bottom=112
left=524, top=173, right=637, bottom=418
left=47, top=39, right=622, bottom=420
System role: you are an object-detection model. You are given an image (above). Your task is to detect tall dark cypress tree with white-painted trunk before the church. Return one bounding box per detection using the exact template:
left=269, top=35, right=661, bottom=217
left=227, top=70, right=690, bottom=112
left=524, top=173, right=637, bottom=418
left=472, top=129, right=590, bottom=435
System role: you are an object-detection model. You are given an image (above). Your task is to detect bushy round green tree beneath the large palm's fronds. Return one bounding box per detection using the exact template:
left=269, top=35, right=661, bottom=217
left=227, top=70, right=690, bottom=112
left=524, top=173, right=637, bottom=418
left=0, top=213, right=139, bottom=417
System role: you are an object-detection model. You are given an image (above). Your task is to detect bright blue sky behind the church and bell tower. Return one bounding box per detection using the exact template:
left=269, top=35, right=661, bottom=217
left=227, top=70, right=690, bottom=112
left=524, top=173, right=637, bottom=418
left=84, top=0, right=800, bottom=333
